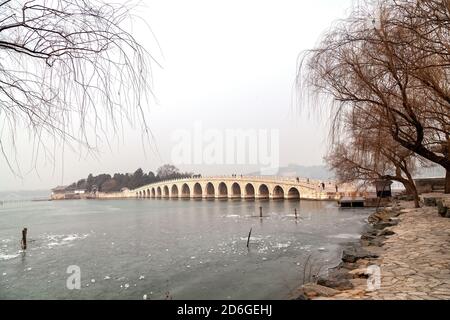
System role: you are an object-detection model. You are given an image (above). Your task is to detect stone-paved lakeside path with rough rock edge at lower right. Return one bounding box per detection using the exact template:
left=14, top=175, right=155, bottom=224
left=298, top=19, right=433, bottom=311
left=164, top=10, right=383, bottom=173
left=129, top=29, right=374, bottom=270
left=296, top=196, right=450, bottom=300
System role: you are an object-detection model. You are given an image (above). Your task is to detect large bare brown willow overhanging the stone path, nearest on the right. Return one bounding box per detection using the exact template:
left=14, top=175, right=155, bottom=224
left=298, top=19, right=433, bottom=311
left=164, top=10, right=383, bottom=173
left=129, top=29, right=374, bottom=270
left=299, top=0, right=450, bottom=193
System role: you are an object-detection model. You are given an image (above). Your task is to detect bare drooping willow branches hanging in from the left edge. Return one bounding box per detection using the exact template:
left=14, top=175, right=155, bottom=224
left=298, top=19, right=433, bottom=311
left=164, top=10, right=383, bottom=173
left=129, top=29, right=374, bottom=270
left=0, top=0, right=152, bottom=175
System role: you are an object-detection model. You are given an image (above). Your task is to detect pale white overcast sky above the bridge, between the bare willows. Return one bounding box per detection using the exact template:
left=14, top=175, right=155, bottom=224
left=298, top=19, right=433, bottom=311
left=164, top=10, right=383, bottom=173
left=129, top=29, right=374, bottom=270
left=0, top=0, right=351, bottom=190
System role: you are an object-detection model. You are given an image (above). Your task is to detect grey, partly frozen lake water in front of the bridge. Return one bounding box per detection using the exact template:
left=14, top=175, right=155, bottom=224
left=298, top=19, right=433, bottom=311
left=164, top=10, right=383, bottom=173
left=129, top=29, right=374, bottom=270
left=0, top=195, right=370, bottom=299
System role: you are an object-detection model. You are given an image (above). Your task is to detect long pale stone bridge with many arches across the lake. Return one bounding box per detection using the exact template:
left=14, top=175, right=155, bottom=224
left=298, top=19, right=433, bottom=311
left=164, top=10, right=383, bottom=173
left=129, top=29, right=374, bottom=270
left=129, top=176, right=336, bottom=200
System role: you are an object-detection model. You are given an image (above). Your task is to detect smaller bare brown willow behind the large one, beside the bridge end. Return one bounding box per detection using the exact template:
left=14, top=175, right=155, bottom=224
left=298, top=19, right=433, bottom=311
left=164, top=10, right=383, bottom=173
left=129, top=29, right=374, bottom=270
left=326, top=108, right=419, bottom=207
